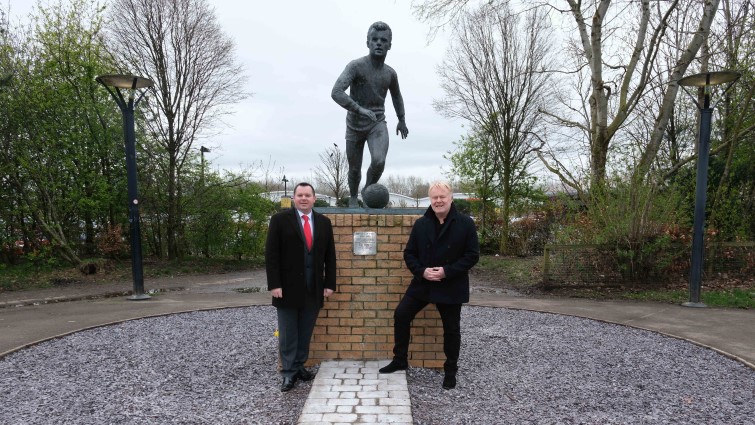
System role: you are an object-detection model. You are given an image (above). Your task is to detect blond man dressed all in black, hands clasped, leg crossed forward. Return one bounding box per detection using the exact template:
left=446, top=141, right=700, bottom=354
left=380, top=182, right=480, bottom=390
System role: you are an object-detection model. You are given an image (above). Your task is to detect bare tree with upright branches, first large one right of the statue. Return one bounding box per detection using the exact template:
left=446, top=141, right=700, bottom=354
left=435, top=5, right=551, bottom=253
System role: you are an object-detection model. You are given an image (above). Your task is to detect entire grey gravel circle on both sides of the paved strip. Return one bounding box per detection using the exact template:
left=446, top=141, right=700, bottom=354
left=0, top=306, right=755, bottom=425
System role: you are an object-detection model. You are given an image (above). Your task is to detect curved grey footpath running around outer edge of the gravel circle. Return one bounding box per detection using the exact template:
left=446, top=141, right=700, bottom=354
left=0, top=270, right=755, bottom=369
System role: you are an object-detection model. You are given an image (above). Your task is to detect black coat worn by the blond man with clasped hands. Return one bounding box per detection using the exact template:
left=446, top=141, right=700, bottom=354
left=404, top=204, right=480, bottom=304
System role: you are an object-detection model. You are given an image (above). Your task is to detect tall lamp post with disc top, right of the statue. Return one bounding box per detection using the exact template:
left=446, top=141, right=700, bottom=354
left=679, top=71, right=740, bottom=307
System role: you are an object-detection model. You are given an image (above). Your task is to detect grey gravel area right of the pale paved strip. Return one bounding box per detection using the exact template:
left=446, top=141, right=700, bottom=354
left=407, top=307, right=755, bottom=425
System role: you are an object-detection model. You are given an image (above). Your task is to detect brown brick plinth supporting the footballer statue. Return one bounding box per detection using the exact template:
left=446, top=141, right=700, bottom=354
left=308, top=210, right=445, bottom=368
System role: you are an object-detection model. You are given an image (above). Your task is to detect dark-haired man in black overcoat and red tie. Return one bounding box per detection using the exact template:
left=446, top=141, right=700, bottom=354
left=265, top=183, right=336, bottom=392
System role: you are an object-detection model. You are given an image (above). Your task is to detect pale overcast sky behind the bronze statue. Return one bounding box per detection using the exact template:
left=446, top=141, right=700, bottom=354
left=10, top=0, right=466, bottom=184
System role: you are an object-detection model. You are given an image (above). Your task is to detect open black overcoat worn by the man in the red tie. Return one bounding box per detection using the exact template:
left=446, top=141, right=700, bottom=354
left=265, top=208, right=336, bottom=308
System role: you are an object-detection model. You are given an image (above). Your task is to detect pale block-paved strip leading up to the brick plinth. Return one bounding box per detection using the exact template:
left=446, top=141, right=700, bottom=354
left=298, top=360, right=412, bottom=425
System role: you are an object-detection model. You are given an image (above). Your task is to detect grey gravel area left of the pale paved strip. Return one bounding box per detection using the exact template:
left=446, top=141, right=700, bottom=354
left=0, top=307, right=311, bottom=425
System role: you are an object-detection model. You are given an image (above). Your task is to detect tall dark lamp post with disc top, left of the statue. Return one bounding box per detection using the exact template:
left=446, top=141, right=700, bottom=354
left=96, top=74, right=154, bottom=300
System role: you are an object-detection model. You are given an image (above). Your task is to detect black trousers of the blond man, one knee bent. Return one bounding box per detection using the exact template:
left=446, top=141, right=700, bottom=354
left=393, top=295, right=461, bottom=375
